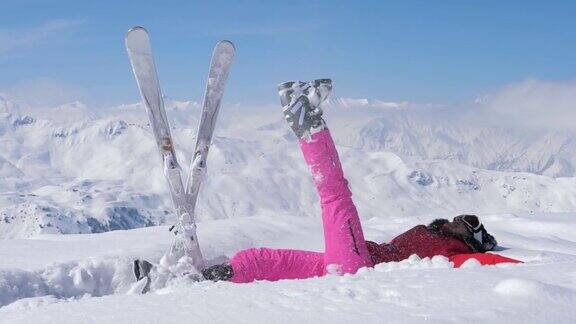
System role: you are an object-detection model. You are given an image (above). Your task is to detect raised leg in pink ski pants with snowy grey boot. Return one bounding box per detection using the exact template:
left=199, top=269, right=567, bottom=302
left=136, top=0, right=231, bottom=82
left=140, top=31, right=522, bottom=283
left=278, top=79, right=372, bottom=273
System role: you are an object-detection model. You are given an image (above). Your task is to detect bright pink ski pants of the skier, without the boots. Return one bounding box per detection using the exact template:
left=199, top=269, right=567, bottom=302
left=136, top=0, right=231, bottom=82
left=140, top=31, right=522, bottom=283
left=230, top=129, right=373, bottom=283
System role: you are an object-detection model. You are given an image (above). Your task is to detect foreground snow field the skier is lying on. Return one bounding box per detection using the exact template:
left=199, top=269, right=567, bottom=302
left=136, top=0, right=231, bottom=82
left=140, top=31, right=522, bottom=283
left=0, top=214, right=576, bottom=323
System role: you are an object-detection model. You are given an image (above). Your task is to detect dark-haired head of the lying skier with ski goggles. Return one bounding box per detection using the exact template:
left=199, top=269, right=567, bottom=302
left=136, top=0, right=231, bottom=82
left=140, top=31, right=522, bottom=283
left=428, top=215, right=497, bottom=252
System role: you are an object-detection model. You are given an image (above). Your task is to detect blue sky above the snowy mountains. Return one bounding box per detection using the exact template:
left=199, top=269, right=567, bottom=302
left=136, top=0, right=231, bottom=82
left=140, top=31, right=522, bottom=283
left=0, top=0, right=576, bottom=105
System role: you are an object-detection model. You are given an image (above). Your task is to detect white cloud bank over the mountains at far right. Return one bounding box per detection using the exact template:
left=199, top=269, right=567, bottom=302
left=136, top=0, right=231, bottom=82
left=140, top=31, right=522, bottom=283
left=316, top=78, right=576, bottom=132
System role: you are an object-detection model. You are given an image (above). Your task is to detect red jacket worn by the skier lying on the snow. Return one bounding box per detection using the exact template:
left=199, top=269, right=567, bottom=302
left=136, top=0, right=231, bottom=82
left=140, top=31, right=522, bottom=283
left=366, top=225, right=520, bottom=267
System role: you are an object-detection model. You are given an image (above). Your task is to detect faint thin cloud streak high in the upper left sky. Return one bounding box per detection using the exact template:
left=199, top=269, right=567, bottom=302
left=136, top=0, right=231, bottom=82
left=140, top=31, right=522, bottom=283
left=0, top=19, right=84, bottom=53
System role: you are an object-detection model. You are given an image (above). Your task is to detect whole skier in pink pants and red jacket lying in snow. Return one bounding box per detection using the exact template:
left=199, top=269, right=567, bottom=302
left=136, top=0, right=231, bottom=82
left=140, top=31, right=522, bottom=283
left=137, top=79, right=520, bottom=283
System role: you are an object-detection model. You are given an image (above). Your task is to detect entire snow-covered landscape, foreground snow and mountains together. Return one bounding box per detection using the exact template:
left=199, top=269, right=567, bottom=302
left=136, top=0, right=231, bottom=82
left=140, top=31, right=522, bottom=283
left=0, top=96, right=576, bottom=323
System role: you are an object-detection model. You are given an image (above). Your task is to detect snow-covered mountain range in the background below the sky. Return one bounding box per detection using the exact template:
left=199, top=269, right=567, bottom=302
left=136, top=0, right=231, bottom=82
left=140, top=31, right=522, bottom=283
left=0, top=96, right=576, bottom=238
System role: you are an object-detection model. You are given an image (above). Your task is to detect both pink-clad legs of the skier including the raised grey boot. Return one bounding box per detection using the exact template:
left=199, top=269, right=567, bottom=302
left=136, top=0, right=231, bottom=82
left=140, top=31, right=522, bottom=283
left=230, top=79, right=373, bottom=283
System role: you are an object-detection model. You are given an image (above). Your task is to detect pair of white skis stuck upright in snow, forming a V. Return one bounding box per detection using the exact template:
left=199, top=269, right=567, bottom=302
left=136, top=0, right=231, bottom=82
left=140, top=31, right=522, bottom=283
left=125, top=27, right=235, bottom=285
